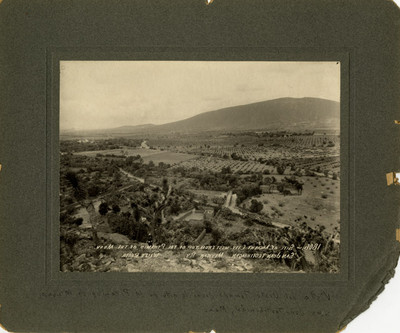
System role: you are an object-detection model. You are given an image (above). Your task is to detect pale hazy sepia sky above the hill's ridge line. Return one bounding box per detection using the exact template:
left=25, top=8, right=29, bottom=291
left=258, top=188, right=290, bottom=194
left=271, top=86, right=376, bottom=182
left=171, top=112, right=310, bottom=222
left=60, top=61, right=340, bottom=130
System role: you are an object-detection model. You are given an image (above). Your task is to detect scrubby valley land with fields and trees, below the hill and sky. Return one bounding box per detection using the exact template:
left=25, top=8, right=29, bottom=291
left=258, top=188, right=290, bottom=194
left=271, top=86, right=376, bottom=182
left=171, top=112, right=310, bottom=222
left=60, top=131, right=340, bottom=273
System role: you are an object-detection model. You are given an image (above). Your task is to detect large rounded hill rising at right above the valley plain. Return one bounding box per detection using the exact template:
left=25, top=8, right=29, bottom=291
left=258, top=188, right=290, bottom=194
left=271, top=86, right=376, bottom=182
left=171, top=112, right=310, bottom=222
left=153, top=98, right=340, bottom=132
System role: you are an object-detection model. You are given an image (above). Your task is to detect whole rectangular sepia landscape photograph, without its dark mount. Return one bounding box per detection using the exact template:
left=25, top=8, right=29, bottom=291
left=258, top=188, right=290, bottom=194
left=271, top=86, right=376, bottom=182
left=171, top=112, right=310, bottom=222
left=59, top=61, right=341, bottom=274
